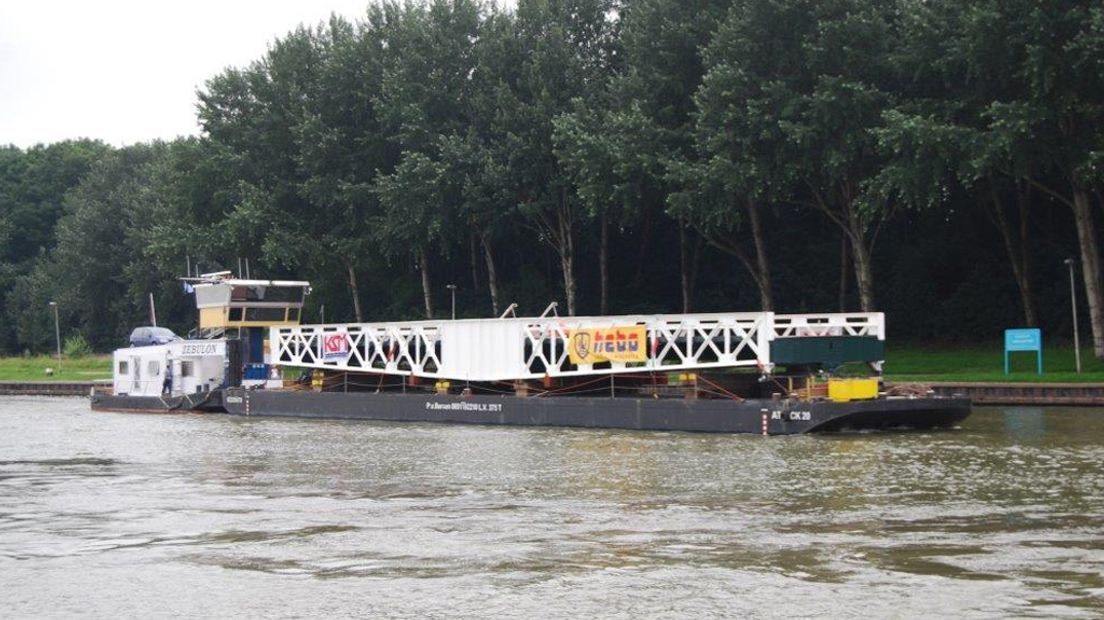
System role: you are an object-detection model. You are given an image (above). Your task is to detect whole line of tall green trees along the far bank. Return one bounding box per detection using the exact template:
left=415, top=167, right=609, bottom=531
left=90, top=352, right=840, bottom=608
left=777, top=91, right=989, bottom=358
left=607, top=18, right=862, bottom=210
left=0, top=0, right=1104, bottom=357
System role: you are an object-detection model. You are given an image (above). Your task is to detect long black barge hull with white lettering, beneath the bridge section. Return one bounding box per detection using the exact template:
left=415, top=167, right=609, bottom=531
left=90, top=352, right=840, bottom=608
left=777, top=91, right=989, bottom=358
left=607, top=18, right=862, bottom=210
left=207, top=388, right=970, bottom=435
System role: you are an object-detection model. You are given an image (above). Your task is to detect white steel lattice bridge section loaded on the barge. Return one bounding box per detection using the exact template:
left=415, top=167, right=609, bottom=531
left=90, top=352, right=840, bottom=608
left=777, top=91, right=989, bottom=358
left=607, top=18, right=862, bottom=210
left=269, top=312, right=885, bottom=381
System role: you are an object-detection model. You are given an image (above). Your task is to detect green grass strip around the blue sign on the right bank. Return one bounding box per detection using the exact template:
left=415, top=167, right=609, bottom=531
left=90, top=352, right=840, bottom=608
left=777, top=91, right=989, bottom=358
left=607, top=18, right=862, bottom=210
left=884, top=342, right=1104, bottom=383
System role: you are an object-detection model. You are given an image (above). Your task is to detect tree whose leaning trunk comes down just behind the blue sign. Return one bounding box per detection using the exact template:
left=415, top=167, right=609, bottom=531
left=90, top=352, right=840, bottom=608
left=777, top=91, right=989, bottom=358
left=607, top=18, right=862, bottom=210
left=872, top=2, right=1038, bottom=325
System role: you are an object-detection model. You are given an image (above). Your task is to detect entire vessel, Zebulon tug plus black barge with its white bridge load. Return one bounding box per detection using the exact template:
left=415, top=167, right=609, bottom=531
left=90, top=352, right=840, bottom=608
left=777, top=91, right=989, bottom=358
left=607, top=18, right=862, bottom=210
left=92, top=272, right=970, bottom=435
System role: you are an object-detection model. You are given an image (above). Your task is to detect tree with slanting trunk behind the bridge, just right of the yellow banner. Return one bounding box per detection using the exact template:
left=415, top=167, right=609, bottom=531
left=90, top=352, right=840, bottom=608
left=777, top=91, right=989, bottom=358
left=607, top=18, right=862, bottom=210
left=681, top=0, right=816, bottom=310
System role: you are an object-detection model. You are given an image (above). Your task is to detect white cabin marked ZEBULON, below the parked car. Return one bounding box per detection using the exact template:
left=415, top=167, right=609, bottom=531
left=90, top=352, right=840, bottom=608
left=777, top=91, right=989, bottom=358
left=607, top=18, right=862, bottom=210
left=113, top=340, right=226, bottom=396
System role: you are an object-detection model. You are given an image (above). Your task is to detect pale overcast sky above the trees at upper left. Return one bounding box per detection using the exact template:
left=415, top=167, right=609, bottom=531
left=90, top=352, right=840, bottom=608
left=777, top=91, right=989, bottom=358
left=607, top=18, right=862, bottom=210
left=0, top=0, right=371, bottom=148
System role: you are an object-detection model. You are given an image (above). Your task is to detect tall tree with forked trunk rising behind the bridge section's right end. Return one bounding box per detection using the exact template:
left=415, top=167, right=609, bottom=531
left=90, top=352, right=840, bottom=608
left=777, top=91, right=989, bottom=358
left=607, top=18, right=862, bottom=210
left=699, top=0, right=894, bottom=311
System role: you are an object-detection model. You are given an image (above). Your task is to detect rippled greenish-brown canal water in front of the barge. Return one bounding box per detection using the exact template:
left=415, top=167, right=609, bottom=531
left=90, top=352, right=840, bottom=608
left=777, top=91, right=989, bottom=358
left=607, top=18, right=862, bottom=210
left=0, top=397, right=1104, bottom=618
